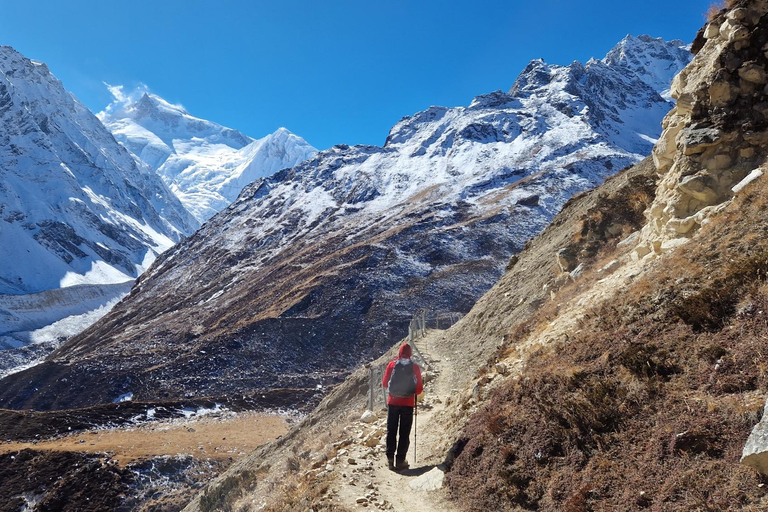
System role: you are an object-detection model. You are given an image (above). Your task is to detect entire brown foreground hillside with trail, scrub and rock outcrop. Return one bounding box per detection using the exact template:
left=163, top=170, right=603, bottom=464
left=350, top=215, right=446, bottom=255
left=187, top=0, right=768, bottom=511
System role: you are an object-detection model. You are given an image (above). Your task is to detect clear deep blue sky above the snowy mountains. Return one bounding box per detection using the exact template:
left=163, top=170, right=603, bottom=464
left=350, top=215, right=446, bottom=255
left=0, top=0, right=713, bottom=149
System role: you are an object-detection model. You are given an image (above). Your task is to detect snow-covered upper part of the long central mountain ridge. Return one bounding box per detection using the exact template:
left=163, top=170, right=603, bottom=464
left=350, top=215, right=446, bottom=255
left=230, top=36, right=690, bottom=251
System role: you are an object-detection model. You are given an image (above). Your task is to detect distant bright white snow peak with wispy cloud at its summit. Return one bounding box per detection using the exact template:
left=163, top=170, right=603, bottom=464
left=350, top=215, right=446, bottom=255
left=98, top=86, right=317, bottom=222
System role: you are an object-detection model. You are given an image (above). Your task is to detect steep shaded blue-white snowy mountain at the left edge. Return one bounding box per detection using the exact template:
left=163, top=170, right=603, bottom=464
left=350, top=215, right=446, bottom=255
left=0, top=46, right=199, bottom=371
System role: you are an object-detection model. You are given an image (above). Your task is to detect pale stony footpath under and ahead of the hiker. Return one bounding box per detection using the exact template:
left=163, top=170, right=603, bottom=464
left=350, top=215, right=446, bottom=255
left=325, top=331, right=464, bottom=512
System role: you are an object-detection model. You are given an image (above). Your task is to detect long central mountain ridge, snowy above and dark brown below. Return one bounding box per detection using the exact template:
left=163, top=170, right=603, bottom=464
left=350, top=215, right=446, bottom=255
left=0, top=37, right=690, bottom=407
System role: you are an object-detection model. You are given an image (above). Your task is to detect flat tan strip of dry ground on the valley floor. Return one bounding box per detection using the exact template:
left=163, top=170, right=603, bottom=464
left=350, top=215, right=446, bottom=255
left=0, top=413, right=289, bottom=466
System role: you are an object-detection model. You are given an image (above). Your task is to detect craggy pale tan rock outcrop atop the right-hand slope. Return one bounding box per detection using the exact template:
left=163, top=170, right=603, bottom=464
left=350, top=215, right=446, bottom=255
left=637, top=1, right=768, bottom=258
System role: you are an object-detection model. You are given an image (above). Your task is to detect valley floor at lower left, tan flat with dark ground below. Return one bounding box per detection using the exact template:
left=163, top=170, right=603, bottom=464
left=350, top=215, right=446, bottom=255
left=0, top=407, right=295, bottom=512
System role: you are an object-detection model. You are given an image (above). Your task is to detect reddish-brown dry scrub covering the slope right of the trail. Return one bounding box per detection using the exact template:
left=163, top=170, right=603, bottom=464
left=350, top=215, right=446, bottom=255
left=447, top=179, right=768, bottom=511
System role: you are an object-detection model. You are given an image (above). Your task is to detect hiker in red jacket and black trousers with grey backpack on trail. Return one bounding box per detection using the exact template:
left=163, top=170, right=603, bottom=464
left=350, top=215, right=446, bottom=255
left=381, top=343, right=424, bottom=470
